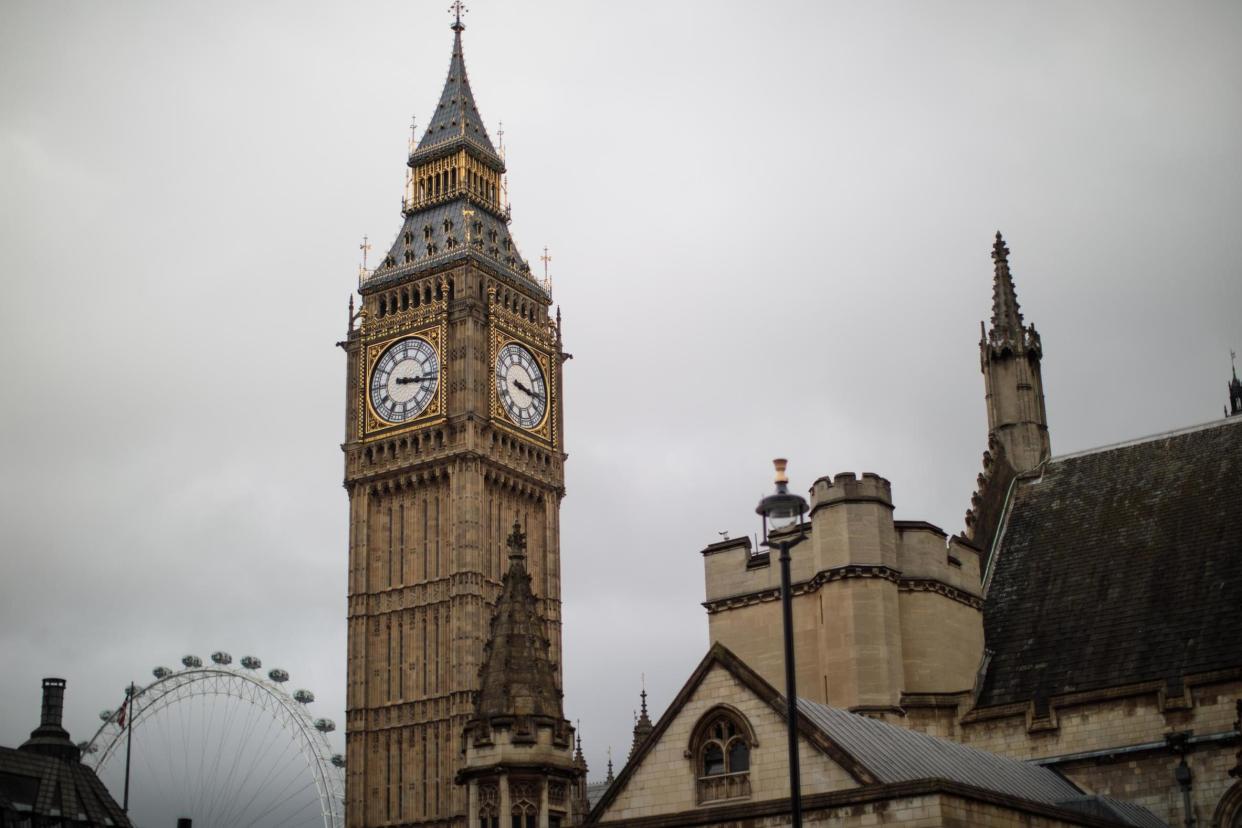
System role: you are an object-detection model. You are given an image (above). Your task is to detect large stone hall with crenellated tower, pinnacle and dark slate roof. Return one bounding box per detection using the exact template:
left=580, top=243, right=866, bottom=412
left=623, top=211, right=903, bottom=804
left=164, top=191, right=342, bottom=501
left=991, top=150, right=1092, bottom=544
left=703, top=235, right=1242, bottom=826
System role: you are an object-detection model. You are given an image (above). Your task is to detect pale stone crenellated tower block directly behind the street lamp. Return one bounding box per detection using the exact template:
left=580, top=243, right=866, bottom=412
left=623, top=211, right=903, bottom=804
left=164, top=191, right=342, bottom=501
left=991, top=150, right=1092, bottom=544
left=703, top=472, right=982, bottom=715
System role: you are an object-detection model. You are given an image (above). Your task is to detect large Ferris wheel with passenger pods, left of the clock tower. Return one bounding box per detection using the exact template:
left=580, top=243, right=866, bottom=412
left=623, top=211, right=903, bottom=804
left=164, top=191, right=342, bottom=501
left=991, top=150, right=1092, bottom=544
left=83, top=655, right=344, bottom=828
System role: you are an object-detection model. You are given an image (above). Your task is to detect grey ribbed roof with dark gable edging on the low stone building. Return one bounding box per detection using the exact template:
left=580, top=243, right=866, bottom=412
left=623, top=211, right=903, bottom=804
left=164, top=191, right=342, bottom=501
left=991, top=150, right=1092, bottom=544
left=589, top=643, right=1163, bottom=826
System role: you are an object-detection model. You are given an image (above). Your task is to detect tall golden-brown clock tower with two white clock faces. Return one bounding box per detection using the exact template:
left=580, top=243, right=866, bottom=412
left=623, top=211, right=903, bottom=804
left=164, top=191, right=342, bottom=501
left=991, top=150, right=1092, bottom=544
left=342, top=4, right=565, bottom=827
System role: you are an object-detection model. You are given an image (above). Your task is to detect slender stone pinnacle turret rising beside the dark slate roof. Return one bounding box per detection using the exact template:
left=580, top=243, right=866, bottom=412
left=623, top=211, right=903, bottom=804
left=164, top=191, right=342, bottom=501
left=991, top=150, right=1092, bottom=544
left=979, top=231, right=1052, bottom=473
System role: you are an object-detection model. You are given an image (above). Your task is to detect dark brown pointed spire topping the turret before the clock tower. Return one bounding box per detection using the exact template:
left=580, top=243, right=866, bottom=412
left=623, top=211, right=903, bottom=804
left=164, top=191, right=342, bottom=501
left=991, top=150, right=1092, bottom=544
left=476, top=520, right=564, bottom=721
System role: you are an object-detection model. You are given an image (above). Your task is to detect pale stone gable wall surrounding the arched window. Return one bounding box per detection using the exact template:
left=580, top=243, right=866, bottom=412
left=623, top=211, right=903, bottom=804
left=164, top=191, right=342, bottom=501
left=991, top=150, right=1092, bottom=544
left=599, top=664, right=858, bottom=823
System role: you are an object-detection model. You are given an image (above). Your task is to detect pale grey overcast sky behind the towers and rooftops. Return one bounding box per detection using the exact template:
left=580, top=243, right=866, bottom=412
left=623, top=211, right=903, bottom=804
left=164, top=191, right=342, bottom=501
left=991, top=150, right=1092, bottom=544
left=0, top=0, right=1242, bottom=814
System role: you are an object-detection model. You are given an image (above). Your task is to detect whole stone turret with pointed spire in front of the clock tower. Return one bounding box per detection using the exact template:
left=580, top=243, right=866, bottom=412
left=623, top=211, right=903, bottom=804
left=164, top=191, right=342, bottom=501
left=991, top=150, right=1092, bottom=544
left=457, top=521, right=586, bottom=828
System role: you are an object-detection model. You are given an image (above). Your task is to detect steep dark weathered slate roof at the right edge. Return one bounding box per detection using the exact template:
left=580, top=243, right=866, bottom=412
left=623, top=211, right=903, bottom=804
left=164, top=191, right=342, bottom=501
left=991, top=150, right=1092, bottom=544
left=979, top=418, right=1242, bottom=706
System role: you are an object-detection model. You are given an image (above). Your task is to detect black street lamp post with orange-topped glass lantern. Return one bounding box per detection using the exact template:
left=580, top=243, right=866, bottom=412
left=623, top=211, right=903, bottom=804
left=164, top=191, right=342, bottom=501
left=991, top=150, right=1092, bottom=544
left=755, top=458, right=806, bottom=828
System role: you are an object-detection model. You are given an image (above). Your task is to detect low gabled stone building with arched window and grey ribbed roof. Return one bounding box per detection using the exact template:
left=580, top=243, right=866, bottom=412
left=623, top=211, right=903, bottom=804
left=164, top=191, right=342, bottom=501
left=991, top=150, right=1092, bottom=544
left=589, top=644, right=1159, bottom=828
